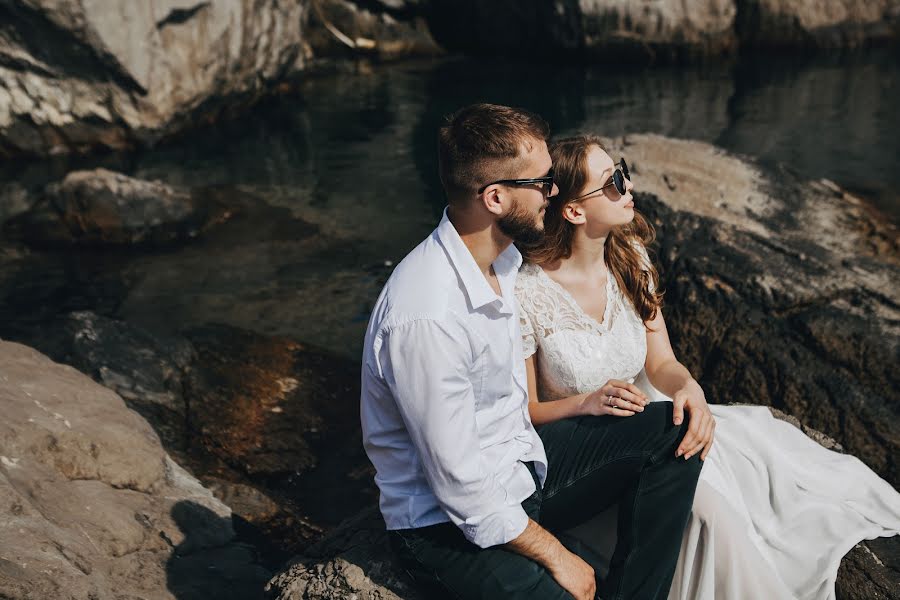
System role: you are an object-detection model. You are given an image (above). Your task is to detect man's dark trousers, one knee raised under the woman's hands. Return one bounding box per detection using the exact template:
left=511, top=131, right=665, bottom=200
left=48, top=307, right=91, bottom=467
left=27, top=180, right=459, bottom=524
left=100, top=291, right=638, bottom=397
left=391, top=402, right=701, bottom=600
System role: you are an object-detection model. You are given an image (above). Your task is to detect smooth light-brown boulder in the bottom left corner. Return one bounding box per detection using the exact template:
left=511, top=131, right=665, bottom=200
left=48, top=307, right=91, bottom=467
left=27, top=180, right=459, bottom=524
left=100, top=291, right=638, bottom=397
left=0, top=342, right=268, bottom=600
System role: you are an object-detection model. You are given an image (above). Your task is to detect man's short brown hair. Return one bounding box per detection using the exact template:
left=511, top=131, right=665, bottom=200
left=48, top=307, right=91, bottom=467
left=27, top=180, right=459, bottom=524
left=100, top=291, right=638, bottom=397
left=438, top=104, right=550, bottom=202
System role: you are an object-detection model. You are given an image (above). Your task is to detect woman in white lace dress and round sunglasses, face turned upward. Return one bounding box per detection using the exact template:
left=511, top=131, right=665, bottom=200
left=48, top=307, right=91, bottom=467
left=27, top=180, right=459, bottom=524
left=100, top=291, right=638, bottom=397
left=516, top=136, right=900, bottom=600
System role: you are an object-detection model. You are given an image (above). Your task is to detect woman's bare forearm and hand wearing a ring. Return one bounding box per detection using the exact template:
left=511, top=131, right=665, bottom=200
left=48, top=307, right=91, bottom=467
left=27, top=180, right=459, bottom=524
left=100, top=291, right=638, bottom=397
left=525, top=354, right=648, bottom=426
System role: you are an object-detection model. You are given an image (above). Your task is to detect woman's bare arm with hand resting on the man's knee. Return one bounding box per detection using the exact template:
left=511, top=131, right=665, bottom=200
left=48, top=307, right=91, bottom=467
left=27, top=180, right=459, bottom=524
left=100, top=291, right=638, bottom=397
left=644, top=310, right=716, bottom=460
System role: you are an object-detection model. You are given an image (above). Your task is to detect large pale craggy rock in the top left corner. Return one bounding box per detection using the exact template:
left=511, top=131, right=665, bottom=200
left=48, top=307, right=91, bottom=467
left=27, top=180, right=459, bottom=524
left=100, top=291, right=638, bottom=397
left=0, top=0, right=308, bottom=156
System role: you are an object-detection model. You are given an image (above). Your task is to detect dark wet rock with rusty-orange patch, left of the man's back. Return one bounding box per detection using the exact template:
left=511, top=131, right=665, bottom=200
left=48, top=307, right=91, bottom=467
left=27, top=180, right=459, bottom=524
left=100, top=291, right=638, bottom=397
left=0, top=311, right=375, bottom=561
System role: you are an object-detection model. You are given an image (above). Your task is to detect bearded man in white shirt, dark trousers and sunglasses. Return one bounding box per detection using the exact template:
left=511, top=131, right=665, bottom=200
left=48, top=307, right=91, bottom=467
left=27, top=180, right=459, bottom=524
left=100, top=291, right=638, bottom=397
left=361, top=104, right=700, bottom=600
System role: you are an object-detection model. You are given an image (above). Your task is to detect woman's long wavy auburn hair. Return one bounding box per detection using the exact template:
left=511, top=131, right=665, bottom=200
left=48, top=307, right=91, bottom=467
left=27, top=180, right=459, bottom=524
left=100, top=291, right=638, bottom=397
left=522, top=135, right=663, bottom=323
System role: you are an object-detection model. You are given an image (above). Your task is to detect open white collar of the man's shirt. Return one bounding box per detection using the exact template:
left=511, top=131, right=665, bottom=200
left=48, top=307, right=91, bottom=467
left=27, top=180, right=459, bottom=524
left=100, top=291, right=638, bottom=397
left=435, top=208, right=522, bottom=309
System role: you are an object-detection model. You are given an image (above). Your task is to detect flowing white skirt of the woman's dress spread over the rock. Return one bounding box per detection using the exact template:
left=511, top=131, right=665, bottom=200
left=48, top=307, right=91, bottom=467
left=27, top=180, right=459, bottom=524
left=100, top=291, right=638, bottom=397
left=571, top=377, right=900, bottom=600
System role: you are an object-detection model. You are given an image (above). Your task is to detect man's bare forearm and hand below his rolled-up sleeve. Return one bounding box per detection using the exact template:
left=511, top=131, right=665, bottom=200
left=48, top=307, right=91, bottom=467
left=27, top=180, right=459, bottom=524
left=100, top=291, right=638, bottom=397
left=504, top=519, right=597, bottom=600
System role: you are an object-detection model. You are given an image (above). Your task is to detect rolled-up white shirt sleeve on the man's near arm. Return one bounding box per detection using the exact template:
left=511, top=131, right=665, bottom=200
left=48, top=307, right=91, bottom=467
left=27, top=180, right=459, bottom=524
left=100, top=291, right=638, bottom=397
left=378, top=318, right=528, bottom=548
